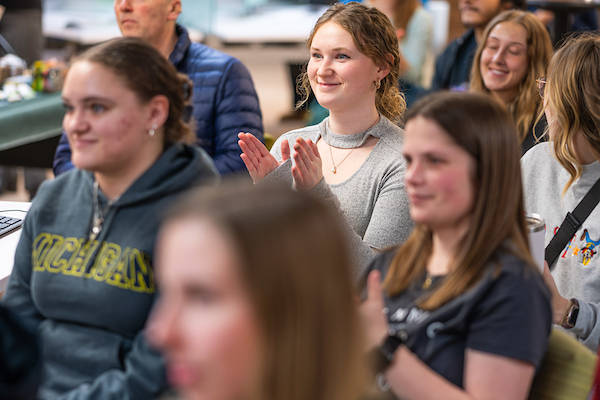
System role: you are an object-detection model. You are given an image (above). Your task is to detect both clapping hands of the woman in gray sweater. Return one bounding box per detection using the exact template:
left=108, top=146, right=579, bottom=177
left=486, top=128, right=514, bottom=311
left=238, top=132, right=323, bottom=192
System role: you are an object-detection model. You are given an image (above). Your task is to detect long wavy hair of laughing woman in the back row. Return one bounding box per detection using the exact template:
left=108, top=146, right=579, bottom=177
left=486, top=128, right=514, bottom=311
left=471, top=10, right=552, bottom=142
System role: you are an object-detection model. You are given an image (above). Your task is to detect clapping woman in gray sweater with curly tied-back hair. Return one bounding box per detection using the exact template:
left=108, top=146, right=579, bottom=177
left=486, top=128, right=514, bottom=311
left=239, top=3, right=412, bottom=276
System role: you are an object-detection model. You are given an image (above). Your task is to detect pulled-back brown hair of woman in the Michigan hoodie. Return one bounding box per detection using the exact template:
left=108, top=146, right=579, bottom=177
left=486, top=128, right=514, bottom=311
left=74, top=37, right=196, bottom=144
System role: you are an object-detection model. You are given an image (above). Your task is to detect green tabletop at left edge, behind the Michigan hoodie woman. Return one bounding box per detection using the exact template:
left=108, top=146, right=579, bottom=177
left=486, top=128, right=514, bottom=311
left=0, top=93, right=65, bottom=151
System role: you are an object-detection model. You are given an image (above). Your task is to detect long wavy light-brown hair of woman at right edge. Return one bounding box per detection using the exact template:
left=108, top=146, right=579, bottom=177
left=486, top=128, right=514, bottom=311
left=545, top=33, right=600, bottom=195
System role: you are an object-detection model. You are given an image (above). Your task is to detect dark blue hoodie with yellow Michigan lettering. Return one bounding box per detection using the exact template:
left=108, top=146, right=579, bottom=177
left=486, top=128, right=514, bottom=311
left=3, top=144, right=218, bottom=400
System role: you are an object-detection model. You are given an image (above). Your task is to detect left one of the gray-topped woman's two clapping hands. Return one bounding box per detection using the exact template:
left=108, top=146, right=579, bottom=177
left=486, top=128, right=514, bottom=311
left=238, top=132, right=290, bottom=183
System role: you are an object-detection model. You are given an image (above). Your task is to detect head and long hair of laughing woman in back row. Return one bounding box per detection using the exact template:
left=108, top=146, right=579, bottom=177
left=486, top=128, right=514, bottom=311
left=471, top=10, right=552, bottom=154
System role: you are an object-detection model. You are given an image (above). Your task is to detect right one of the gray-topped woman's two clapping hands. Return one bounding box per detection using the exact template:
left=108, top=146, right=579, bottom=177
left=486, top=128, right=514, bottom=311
left=292, top=138, right=323, bottom=192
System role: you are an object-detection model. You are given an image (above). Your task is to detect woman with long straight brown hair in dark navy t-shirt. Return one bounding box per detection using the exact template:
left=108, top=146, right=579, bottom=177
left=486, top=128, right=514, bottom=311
left=361, top=93, right=551, bottom=400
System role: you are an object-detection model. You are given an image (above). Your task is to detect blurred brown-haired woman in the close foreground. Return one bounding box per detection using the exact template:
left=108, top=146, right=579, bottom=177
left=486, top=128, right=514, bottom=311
left=149, top=188, right=363, bottom=400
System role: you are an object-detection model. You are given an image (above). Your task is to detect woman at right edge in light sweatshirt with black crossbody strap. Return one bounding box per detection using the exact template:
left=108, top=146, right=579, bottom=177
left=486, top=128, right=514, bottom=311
left=521, top=33, right=600, bottom=350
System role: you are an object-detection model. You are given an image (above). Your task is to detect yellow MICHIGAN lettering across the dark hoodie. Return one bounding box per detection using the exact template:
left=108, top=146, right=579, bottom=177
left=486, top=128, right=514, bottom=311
left=31, top=233, right=155, bottom=293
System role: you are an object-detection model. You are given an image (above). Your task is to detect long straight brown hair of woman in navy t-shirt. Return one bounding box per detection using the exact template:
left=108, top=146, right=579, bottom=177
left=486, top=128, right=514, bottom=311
left=384, top=92, right=535, bottom=310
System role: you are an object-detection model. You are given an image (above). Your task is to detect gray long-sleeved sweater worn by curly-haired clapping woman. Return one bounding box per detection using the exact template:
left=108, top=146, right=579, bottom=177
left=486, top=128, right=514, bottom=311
left=263, top=116, right=413, bottom=277
